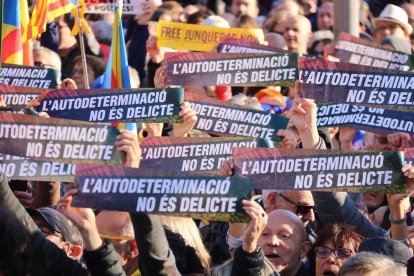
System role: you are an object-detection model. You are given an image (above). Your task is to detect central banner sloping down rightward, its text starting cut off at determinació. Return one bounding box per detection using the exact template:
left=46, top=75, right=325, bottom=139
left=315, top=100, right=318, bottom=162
left=185, top=92, right=289, bottom=142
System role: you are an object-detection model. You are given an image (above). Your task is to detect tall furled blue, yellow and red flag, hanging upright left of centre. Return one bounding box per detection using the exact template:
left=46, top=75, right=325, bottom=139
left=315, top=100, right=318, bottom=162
left=103, top=0, right=136, bottom=131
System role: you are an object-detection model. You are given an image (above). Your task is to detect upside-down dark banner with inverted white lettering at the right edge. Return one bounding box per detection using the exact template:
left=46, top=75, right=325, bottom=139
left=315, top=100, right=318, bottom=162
left=317, top=104, right=414, bottom=134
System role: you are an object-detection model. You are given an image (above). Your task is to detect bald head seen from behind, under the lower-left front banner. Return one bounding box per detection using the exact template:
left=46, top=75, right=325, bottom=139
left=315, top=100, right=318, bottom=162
left=96, top=211, right=134, bottom=238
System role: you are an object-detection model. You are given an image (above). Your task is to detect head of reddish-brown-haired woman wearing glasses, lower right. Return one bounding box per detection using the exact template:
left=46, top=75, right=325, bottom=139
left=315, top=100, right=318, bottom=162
left=308, top=224, right=362, bottom=276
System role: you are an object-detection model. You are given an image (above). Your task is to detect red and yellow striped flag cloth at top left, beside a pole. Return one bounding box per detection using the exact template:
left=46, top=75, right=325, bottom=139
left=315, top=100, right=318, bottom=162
left=22, top=0, right=78, bottom=42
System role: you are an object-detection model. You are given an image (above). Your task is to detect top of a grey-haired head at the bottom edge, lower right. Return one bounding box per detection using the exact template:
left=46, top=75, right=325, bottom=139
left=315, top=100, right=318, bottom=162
left=339, top=252, right=407, bottom=276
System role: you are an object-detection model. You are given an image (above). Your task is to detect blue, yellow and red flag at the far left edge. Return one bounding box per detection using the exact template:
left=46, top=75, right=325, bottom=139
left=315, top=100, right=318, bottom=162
left=1, top=0, right=33, bottom=66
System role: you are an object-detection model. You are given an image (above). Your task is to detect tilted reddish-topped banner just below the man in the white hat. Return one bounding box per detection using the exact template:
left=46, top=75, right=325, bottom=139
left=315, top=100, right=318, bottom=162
left=325, top=33, right=414, bottom=71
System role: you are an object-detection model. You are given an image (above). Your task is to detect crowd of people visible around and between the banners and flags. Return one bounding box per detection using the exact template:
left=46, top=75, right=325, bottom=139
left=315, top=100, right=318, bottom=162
left=4, top=0, right=414, bottom=276
